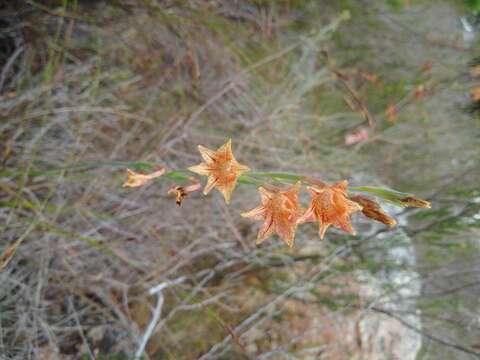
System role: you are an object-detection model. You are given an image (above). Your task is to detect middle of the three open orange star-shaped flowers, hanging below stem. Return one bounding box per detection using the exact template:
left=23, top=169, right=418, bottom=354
left=242, top=182, right=302, bottom=247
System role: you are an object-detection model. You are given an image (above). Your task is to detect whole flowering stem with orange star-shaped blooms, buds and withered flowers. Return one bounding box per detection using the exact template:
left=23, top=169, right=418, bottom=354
left=123, top=140, right=430, bottom=247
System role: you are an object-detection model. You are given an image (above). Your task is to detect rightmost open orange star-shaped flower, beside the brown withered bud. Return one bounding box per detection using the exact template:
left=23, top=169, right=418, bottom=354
left=298, top=180, right=362, bottom=239
